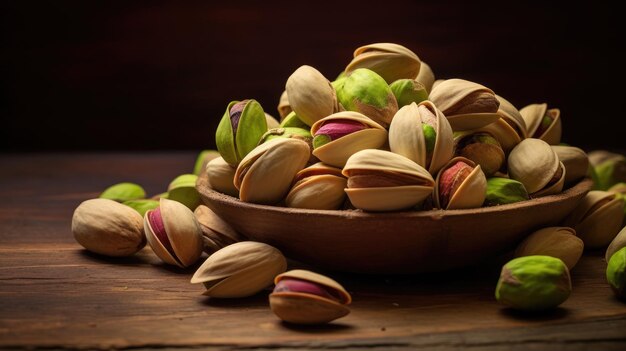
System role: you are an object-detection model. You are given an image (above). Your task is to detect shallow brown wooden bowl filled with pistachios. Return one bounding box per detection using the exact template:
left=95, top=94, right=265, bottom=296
left=196, top=176, right=592, bottom=274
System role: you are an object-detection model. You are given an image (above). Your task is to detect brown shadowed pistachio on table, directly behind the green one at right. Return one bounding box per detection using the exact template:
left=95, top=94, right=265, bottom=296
left=515, top=227, right=584, bottom=271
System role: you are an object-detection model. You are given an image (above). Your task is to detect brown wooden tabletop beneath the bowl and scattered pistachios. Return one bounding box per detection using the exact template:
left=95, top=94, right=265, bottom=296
left=0, top=152, right=626, bottom=350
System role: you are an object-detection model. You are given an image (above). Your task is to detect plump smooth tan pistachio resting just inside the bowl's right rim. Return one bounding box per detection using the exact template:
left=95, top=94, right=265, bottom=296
left=508, top=138, right=560, bottom=195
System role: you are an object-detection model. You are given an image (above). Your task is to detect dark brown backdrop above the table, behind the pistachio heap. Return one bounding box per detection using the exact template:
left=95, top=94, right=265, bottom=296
left=0, top=0, right=624, bottom=151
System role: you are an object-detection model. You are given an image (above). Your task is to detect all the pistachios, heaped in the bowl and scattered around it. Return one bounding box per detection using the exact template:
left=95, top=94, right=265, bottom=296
left=72, top=43, right=626, bottom=323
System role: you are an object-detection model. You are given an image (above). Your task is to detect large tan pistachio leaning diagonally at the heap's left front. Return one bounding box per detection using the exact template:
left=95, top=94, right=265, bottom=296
left=234, top=138, right=311, bottom=204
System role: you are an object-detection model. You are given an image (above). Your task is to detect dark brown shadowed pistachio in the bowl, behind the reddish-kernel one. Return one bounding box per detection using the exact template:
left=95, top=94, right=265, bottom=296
left=455, top=132, right=506, bottom=177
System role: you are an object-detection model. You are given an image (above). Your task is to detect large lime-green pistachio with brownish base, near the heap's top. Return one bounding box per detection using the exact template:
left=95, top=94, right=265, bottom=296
left=337, top=68, right=398, bottom=128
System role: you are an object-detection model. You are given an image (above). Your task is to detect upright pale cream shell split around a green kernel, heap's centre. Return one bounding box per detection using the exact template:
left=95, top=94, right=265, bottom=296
left=389, top=101, right=454, bottom=174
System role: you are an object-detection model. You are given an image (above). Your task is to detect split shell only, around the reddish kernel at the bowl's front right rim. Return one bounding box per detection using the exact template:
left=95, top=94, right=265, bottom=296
left=434, top=157, right=487, bottom=210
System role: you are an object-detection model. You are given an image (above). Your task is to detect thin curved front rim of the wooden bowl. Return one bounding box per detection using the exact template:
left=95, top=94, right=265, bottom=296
left=196, top=175, right=593, bottom=219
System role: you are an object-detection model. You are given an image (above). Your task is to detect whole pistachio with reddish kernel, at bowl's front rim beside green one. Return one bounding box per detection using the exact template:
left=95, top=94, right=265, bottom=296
left=434, top=157, right=487, bottom=210
